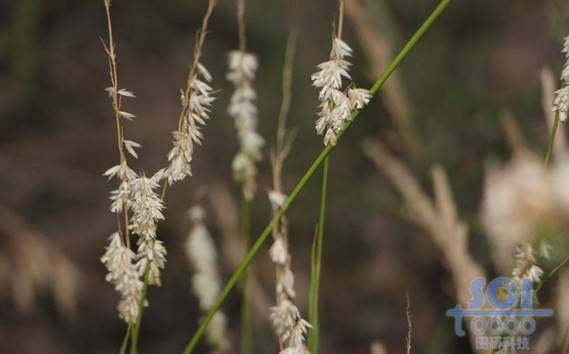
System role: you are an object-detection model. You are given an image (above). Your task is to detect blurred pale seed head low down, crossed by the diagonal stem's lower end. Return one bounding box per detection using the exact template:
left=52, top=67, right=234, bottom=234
left=186, top=207, right=230, bottom=354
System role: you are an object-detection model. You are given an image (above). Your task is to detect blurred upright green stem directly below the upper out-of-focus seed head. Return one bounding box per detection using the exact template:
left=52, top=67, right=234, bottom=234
left=241, top=196, right=253, bottom=354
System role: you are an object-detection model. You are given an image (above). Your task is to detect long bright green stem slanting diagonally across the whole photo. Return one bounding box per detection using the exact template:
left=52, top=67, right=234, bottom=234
left=180, top=0, right=451, bottom=354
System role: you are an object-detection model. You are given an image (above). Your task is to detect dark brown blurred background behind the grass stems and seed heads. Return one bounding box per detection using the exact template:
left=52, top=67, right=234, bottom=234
left=0, top=0, right=569, bottom=354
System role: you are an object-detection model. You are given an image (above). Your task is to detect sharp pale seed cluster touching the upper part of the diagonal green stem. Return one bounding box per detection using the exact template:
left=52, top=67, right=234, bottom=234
left=311, top=37, right=371, bottom=145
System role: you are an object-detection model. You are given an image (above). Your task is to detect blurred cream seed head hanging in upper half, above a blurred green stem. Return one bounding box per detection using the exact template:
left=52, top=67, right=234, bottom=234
left=227, top=51, right=265, bottom=200
